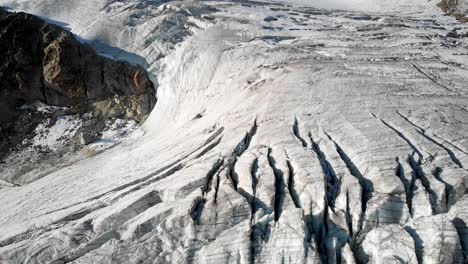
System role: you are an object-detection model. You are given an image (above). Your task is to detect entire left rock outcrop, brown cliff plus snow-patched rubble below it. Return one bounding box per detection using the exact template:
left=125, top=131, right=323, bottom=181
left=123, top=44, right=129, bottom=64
left=0, top=7, right=156, bottom=184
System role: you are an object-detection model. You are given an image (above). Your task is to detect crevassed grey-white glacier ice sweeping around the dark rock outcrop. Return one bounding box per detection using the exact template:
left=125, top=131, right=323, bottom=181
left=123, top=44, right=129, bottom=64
left=0, top=0, right=468, bottom=263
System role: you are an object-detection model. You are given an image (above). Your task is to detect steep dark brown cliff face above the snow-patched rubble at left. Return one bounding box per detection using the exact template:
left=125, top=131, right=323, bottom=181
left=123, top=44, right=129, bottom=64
left=0, top=7, right=156, bottom=122
